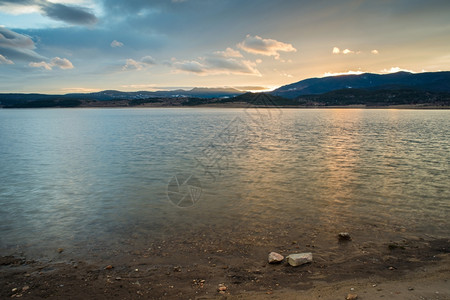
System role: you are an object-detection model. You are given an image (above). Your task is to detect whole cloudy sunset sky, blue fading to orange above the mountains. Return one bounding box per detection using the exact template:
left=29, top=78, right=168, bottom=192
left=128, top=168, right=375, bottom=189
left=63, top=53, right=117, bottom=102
left=0, top=0, right=450, bottom=94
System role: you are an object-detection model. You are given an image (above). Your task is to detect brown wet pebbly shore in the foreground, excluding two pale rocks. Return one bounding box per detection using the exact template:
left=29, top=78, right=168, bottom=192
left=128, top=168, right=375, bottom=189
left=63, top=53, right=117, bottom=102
left=0, top=237, right=450, bottom=300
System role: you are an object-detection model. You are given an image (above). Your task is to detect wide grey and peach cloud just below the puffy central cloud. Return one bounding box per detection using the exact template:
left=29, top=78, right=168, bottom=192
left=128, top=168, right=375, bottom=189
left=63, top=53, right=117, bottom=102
left=172, top=48, right=261, bottom=76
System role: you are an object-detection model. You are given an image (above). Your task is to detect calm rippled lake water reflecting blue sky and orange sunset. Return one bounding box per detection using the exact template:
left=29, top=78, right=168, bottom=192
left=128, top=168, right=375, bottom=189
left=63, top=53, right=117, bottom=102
left=0, top=108, right=450, bottom=258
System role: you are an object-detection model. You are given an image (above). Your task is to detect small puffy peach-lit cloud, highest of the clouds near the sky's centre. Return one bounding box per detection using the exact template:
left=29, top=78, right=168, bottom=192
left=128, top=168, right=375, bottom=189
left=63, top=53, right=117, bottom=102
left=237, top=34, right=297, bottom=59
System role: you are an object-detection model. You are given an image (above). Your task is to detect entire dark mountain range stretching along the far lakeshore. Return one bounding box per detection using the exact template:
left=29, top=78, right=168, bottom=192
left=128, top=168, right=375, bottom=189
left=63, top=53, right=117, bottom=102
left=0, top=71, right=450, bottom=108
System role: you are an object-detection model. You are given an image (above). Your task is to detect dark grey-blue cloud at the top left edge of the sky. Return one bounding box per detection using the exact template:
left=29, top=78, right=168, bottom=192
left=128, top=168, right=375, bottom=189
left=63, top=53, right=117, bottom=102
left=0, top=0, right=98, bottom=25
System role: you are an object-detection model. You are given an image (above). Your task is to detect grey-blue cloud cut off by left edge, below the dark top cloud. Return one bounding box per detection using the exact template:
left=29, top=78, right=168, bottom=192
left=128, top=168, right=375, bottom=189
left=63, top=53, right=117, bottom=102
left=0, top=27, right=46, bottom=61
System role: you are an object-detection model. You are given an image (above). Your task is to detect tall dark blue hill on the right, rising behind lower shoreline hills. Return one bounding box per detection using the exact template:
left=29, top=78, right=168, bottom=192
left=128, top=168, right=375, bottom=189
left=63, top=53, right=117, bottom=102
left=271, top=72, right=450, bottom=99
